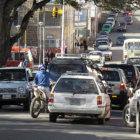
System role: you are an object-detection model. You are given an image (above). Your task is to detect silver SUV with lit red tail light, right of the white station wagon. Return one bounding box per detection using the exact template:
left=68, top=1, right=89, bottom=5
left=101, top=68, right=128, bottom=109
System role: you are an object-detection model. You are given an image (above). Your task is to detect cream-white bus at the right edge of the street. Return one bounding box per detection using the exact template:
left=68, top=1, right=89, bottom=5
left=123, top=39, right=140, bottom=60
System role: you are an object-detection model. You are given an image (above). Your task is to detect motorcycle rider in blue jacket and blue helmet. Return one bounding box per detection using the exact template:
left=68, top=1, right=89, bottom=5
left=33, top=64, right=57, bottom=99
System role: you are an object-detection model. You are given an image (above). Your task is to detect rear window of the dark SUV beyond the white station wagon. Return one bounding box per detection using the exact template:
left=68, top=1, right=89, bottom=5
left=50, top=64, right=83, bottom=77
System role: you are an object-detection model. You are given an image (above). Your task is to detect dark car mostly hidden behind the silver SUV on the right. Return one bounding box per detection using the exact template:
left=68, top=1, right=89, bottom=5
left=104, top=64, right=140, bottom=87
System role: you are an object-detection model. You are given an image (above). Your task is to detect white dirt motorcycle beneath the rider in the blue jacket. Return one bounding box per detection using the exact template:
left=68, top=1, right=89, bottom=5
left=30, top=86, right=51, bottom=118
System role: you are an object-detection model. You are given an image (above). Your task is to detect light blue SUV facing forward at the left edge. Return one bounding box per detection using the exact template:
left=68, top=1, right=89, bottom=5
left=0, top=67, right=33, bottom=110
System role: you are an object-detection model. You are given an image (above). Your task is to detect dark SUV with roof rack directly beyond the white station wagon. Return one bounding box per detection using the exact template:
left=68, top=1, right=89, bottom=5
left=48, top=55, right=88, bottom=78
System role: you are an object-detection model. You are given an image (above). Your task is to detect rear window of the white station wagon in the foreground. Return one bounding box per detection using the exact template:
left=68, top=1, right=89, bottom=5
left=54, top=78, right=98, bottom=94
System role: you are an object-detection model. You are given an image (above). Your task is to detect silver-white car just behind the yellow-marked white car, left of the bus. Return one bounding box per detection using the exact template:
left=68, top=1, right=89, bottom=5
left=97, top=45, right=112, bottom=60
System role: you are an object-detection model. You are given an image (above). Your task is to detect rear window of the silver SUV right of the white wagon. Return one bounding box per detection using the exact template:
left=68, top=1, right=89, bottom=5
left=102, top=71, right=120, bottom=81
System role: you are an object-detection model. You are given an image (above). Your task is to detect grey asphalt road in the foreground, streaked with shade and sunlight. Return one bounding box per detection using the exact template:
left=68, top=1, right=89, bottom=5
left=0, top=106, right=140, bottom=140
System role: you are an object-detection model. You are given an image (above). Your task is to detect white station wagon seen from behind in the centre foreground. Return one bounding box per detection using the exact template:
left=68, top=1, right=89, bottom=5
left=48, top=72, right=111, bottom=124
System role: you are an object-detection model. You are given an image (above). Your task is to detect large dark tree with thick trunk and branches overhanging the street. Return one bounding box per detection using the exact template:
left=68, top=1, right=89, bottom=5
left=0, top=0, right=139, bottom=66
